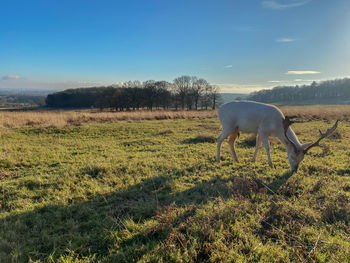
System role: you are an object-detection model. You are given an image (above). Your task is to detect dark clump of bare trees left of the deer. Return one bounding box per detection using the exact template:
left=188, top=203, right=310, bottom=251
left=46, top=76, right=221, bottom=111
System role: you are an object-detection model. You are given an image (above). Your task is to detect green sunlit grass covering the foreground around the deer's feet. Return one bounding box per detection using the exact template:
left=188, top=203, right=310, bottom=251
left=0, top=119, right=350, bottom=262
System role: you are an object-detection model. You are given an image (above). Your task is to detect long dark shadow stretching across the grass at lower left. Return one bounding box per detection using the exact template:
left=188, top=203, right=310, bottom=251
left=0, top=168, right=262, bottom=262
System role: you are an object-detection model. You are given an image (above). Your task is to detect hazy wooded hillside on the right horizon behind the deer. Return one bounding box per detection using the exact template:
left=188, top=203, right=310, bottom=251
left=247, top=78, right=350, bottom=104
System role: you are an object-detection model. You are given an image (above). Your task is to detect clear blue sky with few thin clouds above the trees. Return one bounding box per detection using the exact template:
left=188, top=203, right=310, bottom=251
left=0, top=0, right=350, bottom=93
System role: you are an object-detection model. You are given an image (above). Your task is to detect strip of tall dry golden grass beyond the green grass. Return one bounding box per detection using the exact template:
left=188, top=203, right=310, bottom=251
left=0, top=105, right=350, bottom=128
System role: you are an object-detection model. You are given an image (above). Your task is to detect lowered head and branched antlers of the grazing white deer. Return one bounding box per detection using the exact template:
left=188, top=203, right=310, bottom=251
left=283, top=116, right=338, bottom=172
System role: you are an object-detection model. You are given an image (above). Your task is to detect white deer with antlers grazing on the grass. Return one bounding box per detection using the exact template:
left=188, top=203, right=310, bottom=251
left=216, top=101, right=338, bottom=172
